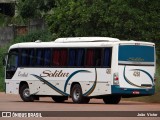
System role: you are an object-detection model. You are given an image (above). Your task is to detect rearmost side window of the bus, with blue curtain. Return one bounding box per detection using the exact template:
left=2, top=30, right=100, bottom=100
left=103, top=48, right=112, bottom=67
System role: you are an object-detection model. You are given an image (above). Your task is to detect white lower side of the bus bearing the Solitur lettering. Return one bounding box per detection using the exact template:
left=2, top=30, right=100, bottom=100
left=7, top=68, right=112, bottom=96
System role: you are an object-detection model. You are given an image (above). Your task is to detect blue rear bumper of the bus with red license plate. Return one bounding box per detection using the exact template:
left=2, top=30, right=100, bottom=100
left=111, top=85, right=155, bottom=97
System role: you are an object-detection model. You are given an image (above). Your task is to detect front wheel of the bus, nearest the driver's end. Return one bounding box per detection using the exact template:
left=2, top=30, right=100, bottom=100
left=20, top=84, right=34, bottom=102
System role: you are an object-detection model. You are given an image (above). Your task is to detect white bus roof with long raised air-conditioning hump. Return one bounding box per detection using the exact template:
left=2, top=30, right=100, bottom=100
left=10, top=37, right=155, bottom=49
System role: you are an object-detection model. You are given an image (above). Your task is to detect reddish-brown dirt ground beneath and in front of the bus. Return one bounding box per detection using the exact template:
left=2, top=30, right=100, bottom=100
left=0, top=93, right=160, bottom=120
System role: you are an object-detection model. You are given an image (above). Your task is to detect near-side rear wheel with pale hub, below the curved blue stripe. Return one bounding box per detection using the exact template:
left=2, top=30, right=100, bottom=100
left=71, top=84, right=84, bottom=104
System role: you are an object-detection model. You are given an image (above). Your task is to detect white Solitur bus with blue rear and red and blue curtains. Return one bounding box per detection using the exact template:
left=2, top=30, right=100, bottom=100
left=5, top=37, right=156, bottom=104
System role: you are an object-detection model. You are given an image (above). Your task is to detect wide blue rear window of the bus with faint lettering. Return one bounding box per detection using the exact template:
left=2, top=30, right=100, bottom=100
left=118, top=45, right=154, bottom=62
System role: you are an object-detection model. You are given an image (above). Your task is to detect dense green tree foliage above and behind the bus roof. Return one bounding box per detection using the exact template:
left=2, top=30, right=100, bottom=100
left=46, top=0, right=160, bottom=41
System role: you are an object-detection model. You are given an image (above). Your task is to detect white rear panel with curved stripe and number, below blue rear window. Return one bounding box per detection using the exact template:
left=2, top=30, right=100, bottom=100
left=119, top=65, right=155, bottom=88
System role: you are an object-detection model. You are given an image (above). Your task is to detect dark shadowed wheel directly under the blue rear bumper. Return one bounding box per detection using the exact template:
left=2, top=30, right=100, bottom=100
left=103, top=95, right=121, bottom=104
